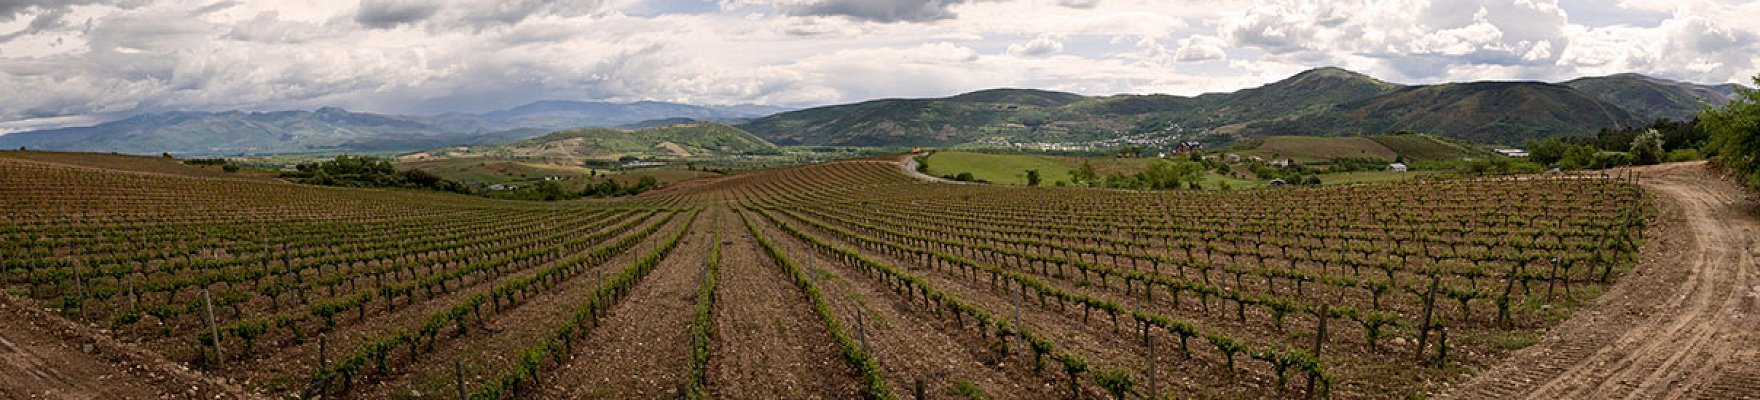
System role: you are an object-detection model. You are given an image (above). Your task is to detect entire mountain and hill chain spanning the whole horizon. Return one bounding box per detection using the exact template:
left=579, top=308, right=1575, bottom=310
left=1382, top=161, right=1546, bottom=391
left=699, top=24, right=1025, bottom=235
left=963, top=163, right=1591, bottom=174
left=0, top=67, right=1735, bottom=155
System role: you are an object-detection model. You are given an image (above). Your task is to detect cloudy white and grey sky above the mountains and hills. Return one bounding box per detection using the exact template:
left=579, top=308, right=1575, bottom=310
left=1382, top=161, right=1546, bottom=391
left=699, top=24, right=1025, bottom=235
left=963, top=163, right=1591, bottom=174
left=0, top=0, right=1760, bottom=132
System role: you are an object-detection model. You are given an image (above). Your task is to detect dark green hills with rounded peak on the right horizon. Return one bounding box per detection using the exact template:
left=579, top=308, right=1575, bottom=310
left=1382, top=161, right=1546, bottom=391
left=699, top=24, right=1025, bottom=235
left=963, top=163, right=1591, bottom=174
left=737, top=67, right=1734, bottom=146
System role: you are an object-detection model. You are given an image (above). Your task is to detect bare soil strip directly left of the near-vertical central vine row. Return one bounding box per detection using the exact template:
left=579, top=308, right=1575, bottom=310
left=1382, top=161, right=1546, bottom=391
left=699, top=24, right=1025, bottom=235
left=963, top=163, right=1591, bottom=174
left=537, top=215, right=715, bottom=398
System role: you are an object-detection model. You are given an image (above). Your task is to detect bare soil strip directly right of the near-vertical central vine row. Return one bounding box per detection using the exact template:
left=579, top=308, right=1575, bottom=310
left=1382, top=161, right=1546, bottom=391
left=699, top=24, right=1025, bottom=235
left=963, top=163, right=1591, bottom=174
left=700, top=210, right=861, bottom=398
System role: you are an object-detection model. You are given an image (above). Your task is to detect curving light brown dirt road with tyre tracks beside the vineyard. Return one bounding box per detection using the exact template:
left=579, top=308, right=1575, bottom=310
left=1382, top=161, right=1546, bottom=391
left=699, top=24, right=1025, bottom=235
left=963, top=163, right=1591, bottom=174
left=1441, top=162, right=1760, bottom=400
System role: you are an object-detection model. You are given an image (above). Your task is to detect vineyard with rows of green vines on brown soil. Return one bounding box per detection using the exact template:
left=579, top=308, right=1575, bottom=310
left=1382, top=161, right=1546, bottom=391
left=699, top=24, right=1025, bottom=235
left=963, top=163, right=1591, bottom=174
left=0, top=151, right=1653, bottom=398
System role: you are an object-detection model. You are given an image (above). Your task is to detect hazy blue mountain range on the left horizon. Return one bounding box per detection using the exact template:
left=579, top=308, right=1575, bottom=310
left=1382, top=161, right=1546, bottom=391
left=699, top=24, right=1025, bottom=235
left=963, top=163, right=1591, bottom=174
left=0, top=100, right=787, bottom=155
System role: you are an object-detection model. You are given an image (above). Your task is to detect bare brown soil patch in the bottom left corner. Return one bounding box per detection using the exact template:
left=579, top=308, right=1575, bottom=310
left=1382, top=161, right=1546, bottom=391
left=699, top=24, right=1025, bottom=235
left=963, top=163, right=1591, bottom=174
left=0, top=294, right=252, bottom=398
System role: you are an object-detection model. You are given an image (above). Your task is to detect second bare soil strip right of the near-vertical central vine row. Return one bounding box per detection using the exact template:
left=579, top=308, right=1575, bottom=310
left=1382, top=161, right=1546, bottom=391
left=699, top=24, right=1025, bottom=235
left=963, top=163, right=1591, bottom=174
left=746, top=213, right=1048, bottom=398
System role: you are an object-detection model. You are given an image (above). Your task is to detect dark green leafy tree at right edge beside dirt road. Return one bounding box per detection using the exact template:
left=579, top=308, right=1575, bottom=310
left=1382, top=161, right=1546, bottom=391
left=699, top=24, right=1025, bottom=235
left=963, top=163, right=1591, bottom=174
left=1698, top=76, right=1760, bottom=187
